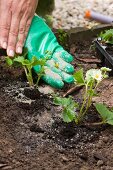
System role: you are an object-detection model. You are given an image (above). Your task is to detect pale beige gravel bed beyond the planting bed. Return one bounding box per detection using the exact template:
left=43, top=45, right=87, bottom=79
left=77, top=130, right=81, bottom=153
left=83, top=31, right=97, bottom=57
left=52, top=0, right=113, bottom=29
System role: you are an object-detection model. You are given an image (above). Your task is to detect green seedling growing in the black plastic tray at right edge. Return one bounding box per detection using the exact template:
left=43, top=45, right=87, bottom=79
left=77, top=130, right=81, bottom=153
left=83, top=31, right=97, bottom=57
left=99, top=29, right=113, bottom=44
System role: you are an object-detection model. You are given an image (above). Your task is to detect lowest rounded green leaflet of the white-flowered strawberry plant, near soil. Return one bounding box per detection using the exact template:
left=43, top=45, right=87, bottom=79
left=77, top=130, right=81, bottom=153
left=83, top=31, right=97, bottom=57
left=62, top=109, right=76, bottom=123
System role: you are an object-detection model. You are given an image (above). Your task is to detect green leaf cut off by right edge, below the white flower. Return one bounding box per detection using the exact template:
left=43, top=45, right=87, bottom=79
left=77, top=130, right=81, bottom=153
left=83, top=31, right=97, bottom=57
left=95, top=103, right=113, bottom=125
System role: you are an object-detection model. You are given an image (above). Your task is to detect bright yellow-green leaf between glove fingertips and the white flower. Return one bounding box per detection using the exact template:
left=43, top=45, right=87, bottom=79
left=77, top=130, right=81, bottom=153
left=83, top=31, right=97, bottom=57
left=73, top=69, right=85, bottom=84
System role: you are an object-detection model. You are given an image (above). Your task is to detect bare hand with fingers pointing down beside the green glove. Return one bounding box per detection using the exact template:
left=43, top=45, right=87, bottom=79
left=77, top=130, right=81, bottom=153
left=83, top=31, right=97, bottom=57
left=0, top=0, right=38, bottom=57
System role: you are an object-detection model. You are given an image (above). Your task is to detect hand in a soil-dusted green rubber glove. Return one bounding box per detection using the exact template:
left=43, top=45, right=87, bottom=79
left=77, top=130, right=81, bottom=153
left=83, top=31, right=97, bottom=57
left=25, top=16, right=74, bottom=88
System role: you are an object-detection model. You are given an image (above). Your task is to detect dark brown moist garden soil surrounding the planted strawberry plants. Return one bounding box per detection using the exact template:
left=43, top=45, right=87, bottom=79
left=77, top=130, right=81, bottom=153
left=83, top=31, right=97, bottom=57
left=0, top=42, right=113, bottom=170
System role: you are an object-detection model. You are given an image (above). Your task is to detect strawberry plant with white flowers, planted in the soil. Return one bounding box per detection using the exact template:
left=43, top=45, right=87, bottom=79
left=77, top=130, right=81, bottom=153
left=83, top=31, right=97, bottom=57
left=54, top=67, right=111, bottom=124
